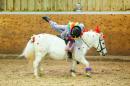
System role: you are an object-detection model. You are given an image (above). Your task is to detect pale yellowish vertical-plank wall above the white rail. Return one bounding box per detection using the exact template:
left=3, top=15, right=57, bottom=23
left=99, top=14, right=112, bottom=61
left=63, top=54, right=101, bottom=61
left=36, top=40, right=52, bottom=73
left=0, top=0, right=130, bottom=11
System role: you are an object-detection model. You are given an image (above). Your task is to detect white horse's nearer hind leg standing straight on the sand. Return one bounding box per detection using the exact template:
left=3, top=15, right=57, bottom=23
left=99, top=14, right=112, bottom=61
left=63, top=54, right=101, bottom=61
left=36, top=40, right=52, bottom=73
left=33, top=52, right=45, bottom=77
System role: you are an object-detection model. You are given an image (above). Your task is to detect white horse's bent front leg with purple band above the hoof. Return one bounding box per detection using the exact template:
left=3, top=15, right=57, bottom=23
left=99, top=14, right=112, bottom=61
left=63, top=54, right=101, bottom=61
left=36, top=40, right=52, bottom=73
left=80, top=57, right=92, bottom=77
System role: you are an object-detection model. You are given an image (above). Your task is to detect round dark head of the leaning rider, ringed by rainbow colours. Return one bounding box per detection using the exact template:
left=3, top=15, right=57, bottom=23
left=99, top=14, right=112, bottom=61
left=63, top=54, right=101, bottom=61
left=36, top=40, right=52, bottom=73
left=70, top=26, right=81, bottom=38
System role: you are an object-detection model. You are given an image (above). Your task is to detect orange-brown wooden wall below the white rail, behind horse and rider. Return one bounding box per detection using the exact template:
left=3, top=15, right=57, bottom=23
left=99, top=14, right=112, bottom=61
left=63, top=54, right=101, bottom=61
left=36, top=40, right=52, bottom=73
left=0, top=14, right=130, bottom=55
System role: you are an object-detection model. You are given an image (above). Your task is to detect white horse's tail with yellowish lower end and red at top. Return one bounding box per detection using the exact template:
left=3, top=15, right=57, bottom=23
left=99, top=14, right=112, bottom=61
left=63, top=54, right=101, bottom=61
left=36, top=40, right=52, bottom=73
left=20, top=36, right=35, bottom=63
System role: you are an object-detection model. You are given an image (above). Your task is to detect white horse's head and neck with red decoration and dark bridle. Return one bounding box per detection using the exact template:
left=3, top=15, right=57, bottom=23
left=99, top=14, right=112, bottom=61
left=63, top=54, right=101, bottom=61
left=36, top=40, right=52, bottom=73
left=82, top=27, right=107, bottom=56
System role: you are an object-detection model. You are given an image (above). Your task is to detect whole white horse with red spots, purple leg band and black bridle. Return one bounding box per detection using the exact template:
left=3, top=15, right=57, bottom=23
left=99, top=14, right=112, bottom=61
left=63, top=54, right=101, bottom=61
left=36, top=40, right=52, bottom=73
left=21, top=28, right=107, bottom=77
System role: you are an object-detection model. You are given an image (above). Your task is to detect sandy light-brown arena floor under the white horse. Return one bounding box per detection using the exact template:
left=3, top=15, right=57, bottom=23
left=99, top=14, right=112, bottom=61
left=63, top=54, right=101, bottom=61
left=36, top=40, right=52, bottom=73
left=0, top=56, right=130, bottom=86
